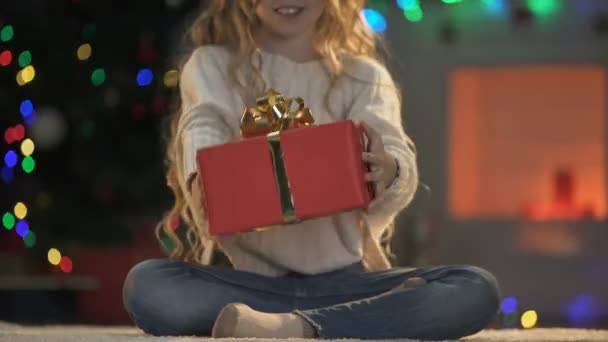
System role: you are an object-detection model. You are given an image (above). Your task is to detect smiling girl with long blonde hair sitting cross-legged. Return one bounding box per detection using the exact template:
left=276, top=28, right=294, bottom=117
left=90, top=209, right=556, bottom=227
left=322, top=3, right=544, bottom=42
left=124, top=0, right=499, bottom=339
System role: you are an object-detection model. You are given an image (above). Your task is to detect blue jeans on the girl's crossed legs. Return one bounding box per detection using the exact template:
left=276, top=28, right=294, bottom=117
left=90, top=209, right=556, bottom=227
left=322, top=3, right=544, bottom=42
left=123, top=259, right=499, bottom=340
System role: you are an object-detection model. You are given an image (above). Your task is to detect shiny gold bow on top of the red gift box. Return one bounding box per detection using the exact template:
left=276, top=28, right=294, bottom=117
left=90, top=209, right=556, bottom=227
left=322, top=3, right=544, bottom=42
left=241, top=88, right=315, bottom=138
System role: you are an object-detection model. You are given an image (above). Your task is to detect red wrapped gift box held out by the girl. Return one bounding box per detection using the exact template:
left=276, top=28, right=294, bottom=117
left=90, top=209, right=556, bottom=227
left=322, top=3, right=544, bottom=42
left=197, top=121, right=371, bottom=235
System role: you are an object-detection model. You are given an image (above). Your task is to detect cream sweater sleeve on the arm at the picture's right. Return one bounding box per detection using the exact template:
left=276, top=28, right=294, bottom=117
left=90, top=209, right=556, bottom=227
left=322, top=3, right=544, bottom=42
left=347, top=60, right=418, bottom=241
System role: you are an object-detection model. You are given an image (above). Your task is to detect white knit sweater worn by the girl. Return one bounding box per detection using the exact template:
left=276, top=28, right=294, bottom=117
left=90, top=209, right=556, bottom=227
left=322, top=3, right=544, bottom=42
left=180, top=46, right=418, bottom=276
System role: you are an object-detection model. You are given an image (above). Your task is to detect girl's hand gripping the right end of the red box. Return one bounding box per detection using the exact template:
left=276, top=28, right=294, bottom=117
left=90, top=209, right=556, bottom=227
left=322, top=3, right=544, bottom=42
left=360, top=121, right=398, bottom=207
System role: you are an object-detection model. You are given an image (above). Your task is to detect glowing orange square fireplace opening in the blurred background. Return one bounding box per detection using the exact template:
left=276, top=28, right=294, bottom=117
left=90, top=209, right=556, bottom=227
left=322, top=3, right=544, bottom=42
left=448, top=66, right=608, bottom=220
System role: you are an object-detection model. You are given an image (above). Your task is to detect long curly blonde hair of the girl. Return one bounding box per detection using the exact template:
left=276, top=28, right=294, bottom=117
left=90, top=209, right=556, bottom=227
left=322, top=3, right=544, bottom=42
left=156, top=0, right=402, bottom=263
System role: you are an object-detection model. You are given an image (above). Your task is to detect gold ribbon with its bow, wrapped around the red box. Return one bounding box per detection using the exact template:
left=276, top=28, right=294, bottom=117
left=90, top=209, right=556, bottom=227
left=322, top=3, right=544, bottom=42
left=241, top=88, right=314, bottom=226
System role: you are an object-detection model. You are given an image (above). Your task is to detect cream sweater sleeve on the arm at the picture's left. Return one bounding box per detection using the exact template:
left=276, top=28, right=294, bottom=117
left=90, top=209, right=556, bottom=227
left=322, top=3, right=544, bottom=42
left=178, top=47, right=238, bottom=184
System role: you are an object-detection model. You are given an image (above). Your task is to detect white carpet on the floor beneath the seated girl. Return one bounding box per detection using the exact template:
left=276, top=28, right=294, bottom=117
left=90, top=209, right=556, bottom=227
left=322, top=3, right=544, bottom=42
left=0, top=322, right=608, bottom=342
